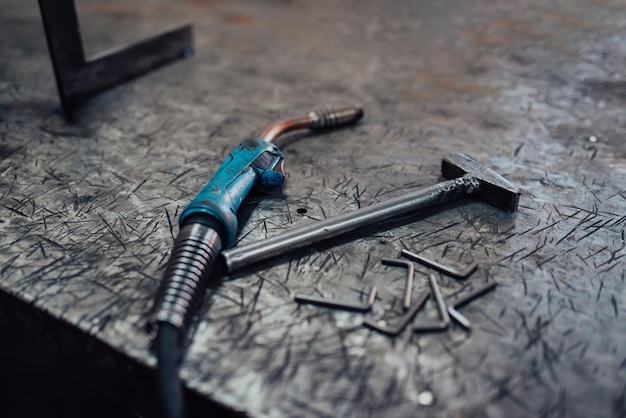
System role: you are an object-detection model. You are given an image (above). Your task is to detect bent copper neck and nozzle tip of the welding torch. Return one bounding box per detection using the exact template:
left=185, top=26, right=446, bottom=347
left=260, top=106, right=363, bottom=142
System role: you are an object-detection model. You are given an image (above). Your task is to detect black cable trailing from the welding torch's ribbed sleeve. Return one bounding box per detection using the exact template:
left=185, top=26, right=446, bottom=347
left=156, top=322, right=185, bottom=418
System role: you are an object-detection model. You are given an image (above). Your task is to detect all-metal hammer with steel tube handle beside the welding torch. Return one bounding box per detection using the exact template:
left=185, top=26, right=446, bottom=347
left=221, top=154, right=520, bottom=273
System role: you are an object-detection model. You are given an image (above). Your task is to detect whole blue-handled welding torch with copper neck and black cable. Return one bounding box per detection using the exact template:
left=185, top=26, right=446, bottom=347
left=149, top=107, right=363, bottom=418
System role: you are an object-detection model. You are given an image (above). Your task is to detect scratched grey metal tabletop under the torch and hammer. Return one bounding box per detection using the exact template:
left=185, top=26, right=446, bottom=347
left=0, top=0, right=626, bottom=417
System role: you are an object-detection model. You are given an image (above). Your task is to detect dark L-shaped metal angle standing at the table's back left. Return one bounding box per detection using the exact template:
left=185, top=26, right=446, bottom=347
left=39, top=0, right=193, bottom=117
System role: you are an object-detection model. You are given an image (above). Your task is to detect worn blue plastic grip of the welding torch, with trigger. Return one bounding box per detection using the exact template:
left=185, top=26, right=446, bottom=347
left=179, top=138, right=284, bottom=247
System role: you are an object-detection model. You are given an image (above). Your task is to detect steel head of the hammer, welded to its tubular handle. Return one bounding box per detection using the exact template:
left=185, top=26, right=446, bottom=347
left=441, top=154, right=521, bottom=211
